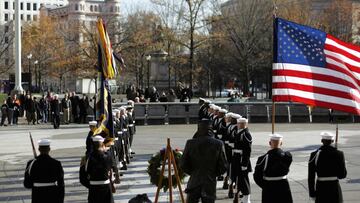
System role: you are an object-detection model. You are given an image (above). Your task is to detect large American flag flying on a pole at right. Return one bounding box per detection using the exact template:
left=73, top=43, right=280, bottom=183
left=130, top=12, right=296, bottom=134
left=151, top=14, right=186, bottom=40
left=273, top=18, right=360, bottom=115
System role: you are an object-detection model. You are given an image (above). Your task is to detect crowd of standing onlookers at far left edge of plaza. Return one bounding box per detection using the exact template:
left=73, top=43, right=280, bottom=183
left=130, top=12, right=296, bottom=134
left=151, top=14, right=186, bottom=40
left=1, top=91, right=89, bottom=128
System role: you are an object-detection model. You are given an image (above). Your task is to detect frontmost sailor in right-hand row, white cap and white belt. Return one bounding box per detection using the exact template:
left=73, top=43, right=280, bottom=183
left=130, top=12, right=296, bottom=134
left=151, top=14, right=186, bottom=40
left=231, top=118, right=252, bottom=203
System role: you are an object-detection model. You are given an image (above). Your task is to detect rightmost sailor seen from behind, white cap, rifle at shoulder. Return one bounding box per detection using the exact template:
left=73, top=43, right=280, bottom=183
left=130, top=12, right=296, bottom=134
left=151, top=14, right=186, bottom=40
left=308, top=132, right=347, bottom=203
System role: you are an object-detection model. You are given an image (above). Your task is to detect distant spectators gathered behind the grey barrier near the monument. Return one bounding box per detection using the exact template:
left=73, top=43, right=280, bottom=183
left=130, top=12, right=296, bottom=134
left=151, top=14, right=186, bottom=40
left=126, top=85, right=193, bottom=103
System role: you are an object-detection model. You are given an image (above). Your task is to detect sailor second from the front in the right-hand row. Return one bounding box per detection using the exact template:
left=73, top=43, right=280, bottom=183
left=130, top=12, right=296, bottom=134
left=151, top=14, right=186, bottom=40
left=227, top=113, right=241, bottom=198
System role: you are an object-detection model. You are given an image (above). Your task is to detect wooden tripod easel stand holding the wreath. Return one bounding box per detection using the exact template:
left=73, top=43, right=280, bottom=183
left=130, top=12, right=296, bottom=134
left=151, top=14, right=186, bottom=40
left=155, top=138, right=185, bottom=203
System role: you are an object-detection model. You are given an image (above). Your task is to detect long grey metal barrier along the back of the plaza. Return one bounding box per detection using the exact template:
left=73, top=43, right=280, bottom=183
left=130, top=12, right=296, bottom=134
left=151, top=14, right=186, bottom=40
left=113, top=102, right=360, bottom=125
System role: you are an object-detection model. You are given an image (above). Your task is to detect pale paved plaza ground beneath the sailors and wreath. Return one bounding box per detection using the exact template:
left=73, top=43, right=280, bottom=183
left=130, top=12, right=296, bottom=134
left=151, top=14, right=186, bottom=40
left=0, top=124, right=360, bottom=203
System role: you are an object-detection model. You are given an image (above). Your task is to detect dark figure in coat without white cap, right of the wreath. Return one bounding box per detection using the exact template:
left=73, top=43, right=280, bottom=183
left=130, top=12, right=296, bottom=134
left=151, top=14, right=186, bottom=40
left=180, top=120, right=228, bottom=203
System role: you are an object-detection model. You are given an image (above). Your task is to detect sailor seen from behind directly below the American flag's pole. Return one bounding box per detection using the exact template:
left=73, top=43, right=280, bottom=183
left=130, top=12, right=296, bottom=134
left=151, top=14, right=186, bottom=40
left=254, top=134, right=293, bottom=203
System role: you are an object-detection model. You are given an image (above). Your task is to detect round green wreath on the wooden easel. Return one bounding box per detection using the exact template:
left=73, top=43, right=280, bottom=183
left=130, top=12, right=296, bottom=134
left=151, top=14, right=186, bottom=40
left=147, top=149, right=185, bottom=192
